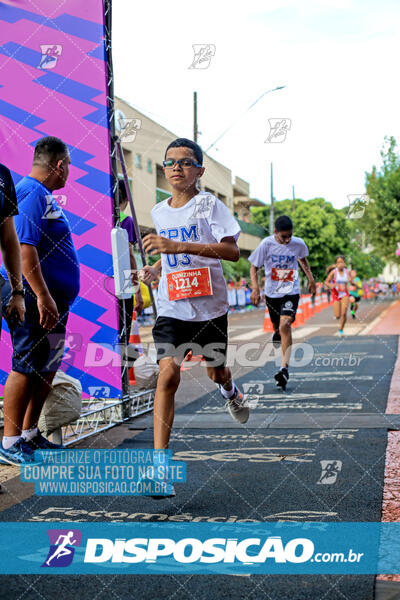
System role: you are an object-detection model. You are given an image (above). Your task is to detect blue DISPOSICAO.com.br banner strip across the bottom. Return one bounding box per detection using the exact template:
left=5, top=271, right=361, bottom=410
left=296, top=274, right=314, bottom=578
left=0, top=522, right=400, bottom=575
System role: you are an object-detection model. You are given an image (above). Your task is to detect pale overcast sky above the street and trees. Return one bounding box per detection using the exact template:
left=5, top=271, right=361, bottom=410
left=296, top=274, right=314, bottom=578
left=113, top=0, right=400, bottom=207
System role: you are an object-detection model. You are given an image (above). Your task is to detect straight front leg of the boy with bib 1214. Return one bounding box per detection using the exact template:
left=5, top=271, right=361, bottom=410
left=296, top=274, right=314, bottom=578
left=154, top=357, right=181, bottom=450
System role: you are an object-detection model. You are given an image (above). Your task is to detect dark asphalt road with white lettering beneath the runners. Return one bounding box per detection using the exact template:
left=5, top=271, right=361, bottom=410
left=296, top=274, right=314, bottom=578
left=0, top=301, right=400, bottom=600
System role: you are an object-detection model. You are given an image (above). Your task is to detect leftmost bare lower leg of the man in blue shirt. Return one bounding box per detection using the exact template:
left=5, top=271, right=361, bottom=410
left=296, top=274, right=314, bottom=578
left=3, top=371, right=33, bottom=437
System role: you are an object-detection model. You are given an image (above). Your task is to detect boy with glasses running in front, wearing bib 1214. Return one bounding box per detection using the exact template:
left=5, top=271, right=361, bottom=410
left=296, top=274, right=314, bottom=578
left=141, top=138, right=249, bottom=449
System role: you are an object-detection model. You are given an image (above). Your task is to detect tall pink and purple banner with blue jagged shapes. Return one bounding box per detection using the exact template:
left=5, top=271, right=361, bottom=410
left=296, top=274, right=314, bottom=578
left=0, top=0, right=121, bottom=398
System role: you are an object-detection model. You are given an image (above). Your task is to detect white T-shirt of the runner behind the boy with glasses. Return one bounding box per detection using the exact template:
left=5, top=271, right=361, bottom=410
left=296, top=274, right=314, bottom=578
left=249, top=235, right=308, bottom=298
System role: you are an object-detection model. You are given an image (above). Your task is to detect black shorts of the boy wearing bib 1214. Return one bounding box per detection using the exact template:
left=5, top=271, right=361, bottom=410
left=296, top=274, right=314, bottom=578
left=153, top=314, right=228, bottom=367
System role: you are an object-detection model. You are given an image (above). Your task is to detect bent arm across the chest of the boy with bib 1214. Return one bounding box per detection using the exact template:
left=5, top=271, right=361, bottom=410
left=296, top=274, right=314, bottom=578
left=143, top=233, right=240, bottom=262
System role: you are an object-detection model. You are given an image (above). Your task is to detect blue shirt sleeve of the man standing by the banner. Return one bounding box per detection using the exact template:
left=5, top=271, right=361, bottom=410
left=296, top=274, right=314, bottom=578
left=14, top=185, right=47, bottom=246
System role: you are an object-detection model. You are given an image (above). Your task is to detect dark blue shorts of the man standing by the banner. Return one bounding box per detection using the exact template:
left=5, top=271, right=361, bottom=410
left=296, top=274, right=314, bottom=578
left=1, top=281, right=69, bottom=375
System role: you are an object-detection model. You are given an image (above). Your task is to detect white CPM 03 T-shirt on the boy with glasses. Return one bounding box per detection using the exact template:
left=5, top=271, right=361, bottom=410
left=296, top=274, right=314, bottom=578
left=151, top=192, right=241, bottom=321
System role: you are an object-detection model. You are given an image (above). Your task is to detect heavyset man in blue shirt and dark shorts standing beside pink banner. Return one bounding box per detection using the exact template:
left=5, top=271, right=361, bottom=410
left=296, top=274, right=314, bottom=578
left=0, top=137, right=79, bottom=464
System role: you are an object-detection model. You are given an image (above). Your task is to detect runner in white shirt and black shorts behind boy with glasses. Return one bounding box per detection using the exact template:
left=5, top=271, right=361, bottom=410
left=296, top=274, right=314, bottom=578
left=249, top=216, right=316, bottom=390
